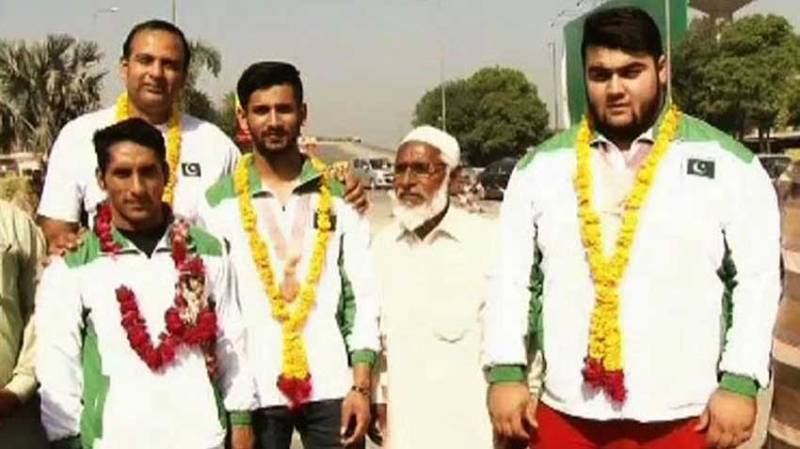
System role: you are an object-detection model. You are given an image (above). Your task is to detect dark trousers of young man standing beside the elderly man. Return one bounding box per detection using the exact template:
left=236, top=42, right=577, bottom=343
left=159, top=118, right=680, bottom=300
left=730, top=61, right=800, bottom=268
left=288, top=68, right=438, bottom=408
left=253, top=399, right=364, bottom=449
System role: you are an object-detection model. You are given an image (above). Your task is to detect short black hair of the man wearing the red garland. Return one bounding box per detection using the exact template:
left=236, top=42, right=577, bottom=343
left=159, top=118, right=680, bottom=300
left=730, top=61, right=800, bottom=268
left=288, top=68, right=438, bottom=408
left=92, top=117, right=167, bottom=173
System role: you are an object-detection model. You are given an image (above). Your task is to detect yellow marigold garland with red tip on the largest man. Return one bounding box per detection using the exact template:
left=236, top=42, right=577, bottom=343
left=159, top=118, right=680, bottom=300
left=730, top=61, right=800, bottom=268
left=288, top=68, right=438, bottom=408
left=575, top=105, right=682, bottom=403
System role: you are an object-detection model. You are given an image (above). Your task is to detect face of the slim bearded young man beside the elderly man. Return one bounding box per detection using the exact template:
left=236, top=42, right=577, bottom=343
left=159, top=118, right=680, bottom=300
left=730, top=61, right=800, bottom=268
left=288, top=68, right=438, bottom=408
left=239, top=84, right=306, bottom=154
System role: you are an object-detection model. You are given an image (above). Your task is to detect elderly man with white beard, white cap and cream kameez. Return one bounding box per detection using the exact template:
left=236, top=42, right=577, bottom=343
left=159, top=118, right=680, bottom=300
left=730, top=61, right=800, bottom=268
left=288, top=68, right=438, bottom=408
left=373, top=126, right=495, bottom=449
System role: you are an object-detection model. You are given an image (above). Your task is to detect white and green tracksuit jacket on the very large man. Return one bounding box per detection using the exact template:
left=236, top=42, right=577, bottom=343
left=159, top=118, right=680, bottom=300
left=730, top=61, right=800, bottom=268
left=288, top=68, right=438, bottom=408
left=485, top=116, right=780, bottom=422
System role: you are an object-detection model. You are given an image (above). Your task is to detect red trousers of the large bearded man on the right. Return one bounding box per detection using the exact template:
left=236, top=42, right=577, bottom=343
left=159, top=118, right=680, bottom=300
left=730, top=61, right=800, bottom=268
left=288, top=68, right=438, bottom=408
left=531, top=402, right=706, bottom=449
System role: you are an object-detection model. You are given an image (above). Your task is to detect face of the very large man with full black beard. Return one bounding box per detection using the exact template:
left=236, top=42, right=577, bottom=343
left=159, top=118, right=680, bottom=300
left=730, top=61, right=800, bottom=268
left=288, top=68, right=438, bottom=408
left=586, top=46, right=667, bottom=139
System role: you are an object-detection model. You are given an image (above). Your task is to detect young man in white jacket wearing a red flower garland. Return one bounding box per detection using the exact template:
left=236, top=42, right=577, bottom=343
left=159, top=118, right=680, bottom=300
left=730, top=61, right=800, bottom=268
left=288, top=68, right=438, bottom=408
left=36, top=119, right=255, bottom=449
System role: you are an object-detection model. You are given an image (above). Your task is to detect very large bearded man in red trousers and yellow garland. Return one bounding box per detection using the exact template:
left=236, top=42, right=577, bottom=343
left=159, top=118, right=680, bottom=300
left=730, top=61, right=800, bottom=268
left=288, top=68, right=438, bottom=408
left=486, top=8, right=780, bottom=449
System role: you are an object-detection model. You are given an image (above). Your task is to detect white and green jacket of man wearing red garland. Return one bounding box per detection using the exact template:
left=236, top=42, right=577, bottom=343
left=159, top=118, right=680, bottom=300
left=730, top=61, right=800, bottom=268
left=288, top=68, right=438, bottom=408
left=36, top=227, right=255, bottom=449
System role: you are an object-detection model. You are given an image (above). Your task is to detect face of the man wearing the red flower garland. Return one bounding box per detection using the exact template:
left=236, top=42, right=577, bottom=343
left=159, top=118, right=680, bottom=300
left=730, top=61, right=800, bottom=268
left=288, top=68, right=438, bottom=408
left=97, top=141, right=166, bottom=231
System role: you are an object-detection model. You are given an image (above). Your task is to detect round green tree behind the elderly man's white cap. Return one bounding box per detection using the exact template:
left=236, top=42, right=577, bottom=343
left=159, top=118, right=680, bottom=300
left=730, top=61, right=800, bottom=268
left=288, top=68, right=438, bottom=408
left=413, top=67, right=549, bottom=166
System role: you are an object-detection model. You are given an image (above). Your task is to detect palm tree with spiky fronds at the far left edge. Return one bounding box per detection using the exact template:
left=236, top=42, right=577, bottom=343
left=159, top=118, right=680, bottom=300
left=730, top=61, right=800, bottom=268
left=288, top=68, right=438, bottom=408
left=0, top=35, right=106, bottom=152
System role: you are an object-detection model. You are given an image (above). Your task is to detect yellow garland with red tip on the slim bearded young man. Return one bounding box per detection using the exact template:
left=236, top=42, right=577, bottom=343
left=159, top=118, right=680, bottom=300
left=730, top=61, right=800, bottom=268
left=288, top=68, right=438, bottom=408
left=234, top=154, right=333, bottom=407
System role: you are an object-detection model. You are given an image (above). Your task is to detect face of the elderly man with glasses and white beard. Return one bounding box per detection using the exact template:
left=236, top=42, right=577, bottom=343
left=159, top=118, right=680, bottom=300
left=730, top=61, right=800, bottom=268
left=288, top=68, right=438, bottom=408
left=394, top=141, right=447, bottom=208
